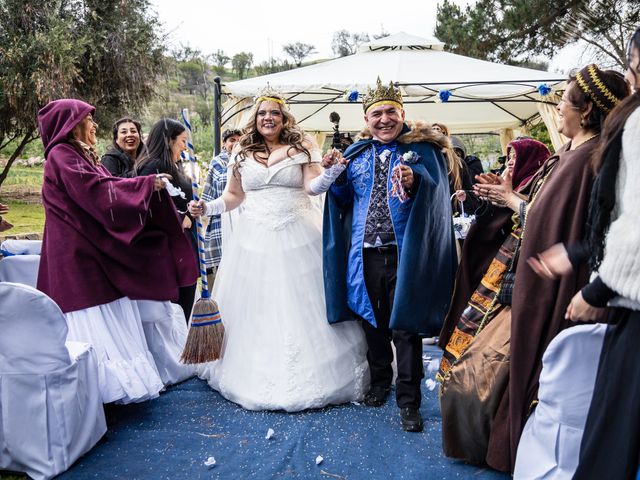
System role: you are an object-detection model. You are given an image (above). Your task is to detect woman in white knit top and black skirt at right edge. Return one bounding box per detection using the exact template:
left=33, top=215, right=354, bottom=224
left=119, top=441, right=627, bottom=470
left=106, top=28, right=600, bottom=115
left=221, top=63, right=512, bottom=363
left=531, top=28, right=640, bottom=480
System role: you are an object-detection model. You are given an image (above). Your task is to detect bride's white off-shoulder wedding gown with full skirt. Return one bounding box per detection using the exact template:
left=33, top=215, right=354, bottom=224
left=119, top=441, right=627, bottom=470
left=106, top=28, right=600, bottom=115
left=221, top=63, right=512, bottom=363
left=200, top=151, right=369, bottom=412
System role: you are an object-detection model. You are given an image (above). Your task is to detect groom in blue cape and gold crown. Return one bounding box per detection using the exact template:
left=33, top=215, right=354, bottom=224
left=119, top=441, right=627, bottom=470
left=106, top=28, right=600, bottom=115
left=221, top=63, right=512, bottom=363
left=323, top=78, right=456, bottom=432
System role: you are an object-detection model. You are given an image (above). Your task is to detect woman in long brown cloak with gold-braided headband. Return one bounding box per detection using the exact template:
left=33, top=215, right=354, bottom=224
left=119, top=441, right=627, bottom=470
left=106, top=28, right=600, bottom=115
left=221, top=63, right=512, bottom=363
left=484, top=65, right=629, bottom=471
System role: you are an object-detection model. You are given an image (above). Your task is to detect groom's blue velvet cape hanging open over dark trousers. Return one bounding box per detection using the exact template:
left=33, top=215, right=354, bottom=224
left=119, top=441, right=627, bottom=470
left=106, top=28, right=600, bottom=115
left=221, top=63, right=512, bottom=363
left=323, top=125, right=457, bottom=336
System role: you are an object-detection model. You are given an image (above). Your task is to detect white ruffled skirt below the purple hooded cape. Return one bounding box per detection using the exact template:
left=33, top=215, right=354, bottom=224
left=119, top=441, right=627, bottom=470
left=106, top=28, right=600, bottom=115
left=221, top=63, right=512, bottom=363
left=66, top=298, right=164, bottom=403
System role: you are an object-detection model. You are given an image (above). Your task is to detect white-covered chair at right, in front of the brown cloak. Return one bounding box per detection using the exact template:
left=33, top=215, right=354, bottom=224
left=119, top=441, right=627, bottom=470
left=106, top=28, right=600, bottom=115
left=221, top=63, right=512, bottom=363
left=514, top=324, right=607, bottom=480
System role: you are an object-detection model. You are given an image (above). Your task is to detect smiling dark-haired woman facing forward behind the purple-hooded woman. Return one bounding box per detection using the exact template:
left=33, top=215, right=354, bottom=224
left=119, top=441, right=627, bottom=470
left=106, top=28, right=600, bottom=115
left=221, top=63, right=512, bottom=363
left=102, top=117, right=144, bottom=177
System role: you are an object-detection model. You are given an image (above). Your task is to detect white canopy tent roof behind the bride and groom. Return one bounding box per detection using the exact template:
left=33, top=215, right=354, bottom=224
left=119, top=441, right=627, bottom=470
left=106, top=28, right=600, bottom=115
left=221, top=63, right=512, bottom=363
left=221, top=33, right=564, bottom=152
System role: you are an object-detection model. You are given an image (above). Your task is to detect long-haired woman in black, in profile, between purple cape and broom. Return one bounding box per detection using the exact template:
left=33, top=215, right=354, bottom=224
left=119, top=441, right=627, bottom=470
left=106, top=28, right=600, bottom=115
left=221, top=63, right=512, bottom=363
left=135, top=118, right=198, bottom=322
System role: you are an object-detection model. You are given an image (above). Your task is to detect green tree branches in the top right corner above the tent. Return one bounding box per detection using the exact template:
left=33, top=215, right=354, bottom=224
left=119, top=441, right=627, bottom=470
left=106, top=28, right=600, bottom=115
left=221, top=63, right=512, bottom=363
left=435, top=0, right=640, bottom=67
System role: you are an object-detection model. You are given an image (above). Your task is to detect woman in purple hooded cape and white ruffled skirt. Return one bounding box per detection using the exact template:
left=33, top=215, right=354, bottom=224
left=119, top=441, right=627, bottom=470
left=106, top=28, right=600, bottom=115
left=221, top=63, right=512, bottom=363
left=38, top=99, right=197, bottom=403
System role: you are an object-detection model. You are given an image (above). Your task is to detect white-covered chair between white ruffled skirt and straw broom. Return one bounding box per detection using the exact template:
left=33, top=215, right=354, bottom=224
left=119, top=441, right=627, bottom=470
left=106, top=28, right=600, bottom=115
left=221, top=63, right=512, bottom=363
left=137, top=300, right=196, bottom=385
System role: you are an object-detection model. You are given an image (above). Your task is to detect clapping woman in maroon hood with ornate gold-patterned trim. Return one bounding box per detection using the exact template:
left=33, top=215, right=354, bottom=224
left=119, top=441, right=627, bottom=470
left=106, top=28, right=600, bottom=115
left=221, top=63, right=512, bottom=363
left=438, top=139, right=550, bottom=463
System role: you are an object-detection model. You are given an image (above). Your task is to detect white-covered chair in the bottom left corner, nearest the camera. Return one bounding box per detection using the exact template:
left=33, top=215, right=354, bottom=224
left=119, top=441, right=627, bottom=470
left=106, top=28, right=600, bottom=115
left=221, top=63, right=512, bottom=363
left=0, top=282, right=107, bottom=480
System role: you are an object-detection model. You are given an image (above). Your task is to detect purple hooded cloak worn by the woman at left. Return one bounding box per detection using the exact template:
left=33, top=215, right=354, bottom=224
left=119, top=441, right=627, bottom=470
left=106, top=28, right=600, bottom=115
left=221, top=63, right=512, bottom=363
left=38, top=99, right=197, bottom=313
